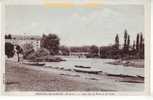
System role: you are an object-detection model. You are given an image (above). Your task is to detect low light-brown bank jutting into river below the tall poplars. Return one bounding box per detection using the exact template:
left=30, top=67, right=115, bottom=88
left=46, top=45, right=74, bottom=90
left=108, top=59, right=144, bottom=68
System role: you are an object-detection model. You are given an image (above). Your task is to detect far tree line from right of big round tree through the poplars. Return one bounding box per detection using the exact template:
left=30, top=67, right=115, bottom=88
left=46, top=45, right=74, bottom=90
left=59, top=29, right=144, bottom=59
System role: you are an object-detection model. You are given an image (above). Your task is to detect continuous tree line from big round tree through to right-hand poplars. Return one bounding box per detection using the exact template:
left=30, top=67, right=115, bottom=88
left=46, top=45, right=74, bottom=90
left=38, top=29, right=144, bottom=59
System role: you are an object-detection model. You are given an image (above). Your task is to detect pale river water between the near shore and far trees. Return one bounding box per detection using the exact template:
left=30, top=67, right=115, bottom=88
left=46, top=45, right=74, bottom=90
left=45, top=56, right=144, bottom=77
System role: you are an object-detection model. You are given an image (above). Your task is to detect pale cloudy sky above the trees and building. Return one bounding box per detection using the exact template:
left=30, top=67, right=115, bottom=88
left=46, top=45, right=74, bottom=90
left=5, top=4, right=144, bottom=46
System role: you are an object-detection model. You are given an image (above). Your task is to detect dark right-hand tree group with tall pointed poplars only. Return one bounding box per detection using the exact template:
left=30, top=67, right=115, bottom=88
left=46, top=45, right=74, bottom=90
left=100, top=30, right=144, bottom=59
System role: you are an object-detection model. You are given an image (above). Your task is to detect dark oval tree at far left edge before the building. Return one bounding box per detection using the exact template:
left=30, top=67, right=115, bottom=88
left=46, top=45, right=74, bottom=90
left=5, top=42, right=15, bottom=58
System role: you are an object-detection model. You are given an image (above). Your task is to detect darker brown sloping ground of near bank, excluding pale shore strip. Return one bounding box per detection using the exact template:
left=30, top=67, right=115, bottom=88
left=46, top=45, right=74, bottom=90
left=5, top=62, right=98, bottom=91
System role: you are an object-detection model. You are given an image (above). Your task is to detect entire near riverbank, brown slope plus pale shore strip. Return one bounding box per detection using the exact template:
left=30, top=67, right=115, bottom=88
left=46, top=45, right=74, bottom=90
left=5, top=60, right=144, bottom=91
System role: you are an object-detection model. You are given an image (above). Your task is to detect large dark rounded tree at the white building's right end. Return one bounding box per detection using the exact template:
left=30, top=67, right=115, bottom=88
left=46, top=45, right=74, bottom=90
left=41, top=34, right=60, bottom=55
